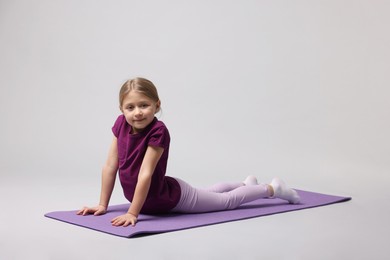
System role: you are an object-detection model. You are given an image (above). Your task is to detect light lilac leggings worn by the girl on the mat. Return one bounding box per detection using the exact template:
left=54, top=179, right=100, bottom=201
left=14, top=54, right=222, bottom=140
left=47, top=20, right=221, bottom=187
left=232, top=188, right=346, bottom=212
left=172, top=178, right=270, bottom=213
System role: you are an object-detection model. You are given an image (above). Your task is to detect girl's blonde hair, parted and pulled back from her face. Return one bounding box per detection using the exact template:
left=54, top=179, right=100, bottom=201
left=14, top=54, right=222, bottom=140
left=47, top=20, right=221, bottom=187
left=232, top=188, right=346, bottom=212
left=119, top=78, right=160, bottom=112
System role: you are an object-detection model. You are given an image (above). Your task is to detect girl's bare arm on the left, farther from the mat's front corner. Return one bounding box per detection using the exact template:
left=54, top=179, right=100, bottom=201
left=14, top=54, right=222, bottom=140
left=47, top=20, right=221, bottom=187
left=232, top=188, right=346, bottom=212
left=77, top=137, right=118, bottom=215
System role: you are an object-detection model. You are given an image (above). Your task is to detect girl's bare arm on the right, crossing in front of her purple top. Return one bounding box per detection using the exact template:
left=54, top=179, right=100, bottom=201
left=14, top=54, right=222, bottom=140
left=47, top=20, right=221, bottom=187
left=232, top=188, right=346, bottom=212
left=111, top=146, right=164, bottom=226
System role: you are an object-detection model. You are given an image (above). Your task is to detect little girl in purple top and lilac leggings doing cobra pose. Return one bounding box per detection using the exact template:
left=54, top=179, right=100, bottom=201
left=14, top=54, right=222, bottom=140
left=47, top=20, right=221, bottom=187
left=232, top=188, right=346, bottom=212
left=77, top=78, right=299, bottom=226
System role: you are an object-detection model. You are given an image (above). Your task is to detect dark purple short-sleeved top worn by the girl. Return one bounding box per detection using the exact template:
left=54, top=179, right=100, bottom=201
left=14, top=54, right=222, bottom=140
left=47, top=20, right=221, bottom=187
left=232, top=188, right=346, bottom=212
left=112, top=115, right=181, bottom=214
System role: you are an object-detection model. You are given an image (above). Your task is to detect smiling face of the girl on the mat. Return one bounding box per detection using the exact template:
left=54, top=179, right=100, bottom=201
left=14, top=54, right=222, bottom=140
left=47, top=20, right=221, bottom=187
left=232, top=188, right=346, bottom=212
left=121, top=90, right=160, bottom=134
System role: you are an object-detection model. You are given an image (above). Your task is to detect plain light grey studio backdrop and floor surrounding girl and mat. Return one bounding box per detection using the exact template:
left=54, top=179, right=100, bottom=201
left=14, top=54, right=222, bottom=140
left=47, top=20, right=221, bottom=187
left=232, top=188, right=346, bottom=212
left=0, top=0, right=390, bottom=259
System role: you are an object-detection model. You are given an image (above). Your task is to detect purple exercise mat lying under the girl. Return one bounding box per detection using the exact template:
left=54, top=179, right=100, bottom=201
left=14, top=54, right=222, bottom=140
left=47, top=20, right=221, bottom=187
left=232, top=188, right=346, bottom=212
left=45, top=190, right=351, bottom=237
